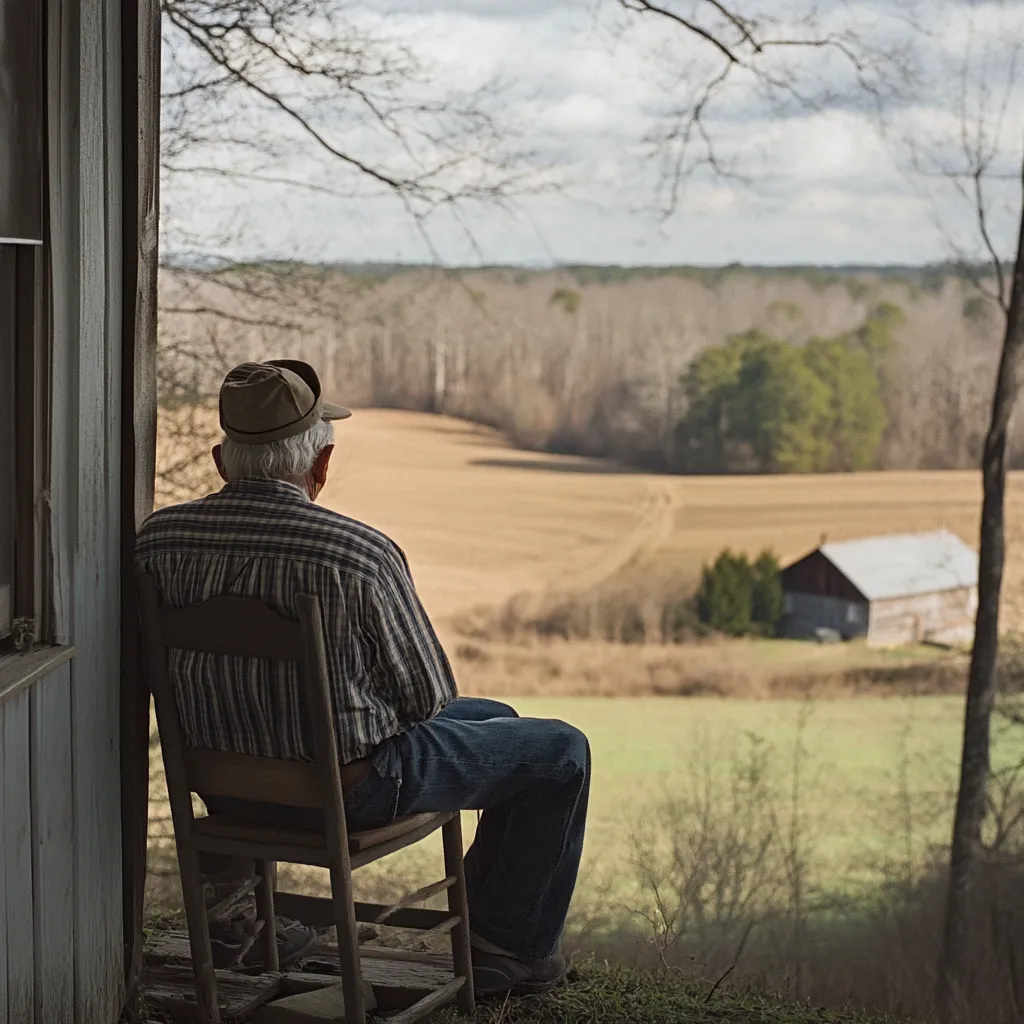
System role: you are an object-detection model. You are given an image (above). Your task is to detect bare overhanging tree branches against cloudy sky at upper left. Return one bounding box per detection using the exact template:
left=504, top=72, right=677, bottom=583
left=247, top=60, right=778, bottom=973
left=162, top=0, right=549, bottom=245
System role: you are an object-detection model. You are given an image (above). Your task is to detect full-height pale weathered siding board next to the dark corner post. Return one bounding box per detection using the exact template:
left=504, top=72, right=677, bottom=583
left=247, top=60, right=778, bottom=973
left=65, top=0, right=124, bottom=1024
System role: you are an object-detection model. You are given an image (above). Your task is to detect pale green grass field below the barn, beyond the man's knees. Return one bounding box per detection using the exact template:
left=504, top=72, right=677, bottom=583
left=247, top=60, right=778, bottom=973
left=292, top=696, right=1024, bottom=925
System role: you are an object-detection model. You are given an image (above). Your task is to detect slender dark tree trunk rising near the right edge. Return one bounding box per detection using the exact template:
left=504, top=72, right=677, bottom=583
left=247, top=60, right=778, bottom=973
left=937, top=163, right=1024, bottom=1020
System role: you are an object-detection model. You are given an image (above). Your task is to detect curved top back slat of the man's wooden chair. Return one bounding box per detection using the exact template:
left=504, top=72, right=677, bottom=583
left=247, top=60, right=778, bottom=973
left=160, top=597, right=303, bottom=662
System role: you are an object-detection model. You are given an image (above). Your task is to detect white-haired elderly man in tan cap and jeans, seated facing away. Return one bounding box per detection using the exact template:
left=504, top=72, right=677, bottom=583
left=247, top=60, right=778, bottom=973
left=136, top=359, right=590, bottom=995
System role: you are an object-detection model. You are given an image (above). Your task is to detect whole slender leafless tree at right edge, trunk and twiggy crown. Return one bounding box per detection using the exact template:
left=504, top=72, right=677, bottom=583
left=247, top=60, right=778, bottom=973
left=910, top=2, right=1024, bottom=1020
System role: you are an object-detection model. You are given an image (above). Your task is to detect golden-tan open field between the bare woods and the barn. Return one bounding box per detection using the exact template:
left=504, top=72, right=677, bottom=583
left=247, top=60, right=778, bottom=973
left=322, top=410, right=1024, bottom=629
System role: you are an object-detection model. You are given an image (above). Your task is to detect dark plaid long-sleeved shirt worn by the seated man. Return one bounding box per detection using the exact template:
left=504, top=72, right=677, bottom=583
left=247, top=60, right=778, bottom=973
left=135, top=480, right=456, bottom=764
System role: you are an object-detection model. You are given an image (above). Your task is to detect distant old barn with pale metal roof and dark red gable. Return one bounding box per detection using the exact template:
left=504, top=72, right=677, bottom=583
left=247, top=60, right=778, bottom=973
left=782, top=530, right=978, bottom=647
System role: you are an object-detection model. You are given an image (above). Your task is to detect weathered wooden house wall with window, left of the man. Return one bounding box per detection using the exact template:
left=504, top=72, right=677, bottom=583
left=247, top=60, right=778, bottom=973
left=0, top=0, right=160, bottom=1024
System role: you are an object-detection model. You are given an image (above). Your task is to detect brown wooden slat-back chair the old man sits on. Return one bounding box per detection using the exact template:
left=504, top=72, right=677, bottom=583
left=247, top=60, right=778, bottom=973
left=139, top=574, right=474, bottom=1024
